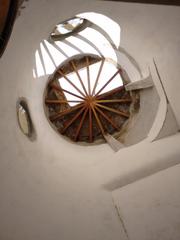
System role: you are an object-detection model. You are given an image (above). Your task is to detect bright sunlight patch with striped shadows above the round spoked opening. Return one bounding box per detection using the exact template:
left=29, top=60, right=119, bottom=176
left=33, top=13, right=120, bottom=78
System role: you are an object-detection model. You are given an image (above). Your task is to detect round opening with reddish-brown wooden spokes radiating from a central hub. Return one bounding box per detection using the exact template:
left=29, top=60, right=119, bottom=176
left=45, top=55, right=133, bottom=143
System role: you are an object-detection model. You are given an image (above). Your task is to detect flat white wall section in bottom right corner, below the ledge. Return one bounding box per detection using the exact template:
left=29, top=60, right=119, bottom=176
left=113, top=165, right=180, bottom=240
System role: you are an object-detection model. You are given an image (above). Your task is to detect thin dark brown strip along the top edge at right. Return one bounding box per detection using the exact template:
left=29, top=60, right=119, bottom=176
left=103, top=0, right=180, bottom=6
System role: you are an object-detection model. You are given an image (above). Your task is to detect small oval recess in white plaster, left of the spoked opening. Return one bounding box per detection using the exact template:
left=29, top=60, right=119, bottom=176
left=16, top=98, right=35, bottom=140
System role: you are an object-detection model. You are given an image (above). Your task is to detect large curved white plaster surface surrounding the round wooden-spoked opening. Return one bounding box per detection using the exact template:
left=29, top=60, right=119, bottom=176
left=0, top=0, right=180, bottom=240
